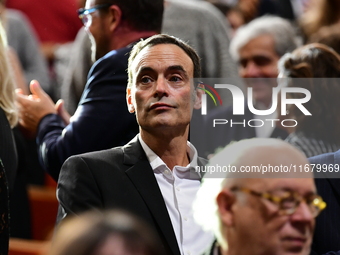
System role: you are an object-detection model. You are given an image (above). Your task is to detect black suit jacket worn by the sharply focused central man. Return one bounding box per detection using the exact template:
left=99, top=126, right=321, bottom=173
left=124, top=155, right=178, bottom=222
left=57, top=137, right=205, bottom=255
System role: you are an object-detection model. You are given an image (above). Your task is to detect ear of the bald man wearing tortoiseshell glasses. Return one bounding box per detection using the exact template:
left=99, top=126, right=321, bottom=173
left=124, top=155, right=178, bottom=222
left=216, top=189, right=236, bottom=226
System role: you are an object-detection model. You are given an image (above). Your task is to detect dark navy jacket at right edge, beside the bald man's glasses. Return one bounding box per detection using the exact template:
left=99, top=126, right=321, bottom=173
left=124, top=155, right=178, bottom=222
left=309, top=150, right=340, bottom=254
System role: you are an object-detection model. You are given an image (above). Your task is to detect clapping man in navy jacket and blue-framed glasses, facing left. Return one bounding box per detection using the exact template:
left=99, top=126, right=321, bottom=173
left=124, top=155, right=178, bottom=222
left=18, top=0, right=163, bottom=180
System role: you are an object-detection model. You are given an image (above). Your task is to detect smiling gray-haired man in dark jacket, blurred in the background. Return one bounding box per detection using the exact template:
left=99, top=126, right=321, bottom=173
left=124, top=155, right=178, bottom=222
left=205, top=16, right=298, bottom=157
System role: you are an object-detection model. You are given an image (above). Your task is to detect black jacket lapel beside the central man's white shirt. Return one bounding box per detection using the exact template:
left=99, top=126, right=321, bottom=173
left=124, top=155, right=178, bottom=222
left=123, top=137, right=180, bottom=254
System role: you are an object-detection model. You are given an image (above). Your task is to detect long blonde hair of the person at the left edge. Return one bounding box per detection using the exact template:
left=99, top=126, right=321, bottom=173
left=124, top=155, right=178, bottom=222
left=0, top=20, right=18, bottom=127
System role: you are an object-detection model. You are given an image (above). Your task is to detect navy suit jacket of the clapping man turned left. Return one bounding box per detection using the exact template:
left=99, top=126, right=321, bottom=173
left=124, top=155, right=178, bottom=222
left=37, top=46, right=138, bottom=180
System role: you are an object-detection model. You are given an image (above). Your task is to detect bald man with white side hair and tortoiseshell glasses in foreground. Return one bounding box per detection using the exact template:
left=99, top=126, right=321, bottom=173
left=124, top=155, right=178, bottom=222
left=194, top=138, right=326, bottom=255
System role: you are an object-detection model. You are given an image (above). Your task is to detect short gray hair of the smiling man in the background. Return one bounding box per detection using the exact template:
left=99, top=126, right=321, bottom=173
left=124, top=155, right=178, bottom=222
left=230, top=15, right=301, bottom=61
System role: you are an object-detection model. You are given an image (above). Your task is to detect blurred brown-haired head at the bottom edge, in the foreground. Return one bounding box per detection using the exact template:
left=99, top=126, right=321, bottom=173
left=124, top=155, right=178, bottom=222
left=48, top=211, right=162, bottom=255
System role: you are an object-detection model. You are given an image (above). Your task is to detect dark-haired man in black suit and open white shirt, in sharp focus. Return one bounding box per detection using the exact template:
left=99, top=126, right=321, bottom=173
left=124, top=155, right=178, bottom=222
left=57, top=35, right=212, bottom=255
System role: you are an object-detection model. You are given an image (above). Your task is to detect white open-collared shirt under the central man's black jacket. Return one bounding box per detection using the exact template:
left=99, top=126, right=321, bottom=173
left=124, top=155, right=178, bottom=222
left=139, top=136, right=213, bottom=255
